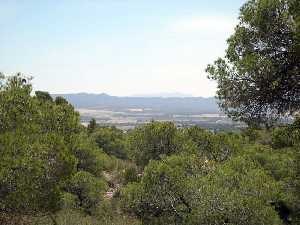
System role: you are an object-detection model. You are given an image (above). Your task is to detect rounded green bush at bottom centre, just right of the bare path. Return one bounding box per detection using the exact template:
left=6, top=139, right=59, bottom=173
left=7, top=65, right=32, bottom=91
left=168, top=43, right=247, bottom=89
left=121, top=155, right=212, bottom=224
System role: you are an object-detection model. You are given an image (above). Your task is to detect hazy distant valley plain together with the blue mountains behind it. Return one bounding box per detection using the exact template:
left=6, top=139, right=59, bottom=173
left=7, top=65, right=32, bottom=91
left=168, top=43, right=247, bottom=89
left=53, top=93, right=242, bottom=131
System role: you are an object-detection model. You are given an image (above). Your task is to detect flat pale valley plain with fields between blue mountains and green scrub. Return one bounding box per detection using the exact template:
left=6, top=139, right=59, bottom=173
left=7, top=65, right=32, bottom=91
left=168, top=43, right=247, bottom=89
left=77, top=108, right=245, bottom=131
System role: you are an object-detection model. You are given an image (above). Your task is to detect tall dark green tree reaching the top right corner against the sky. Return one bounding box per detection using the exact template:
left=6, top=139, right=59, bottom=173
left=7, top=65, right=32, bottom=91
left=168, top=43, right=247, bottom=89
left=207, top=0, right=300, bottom=125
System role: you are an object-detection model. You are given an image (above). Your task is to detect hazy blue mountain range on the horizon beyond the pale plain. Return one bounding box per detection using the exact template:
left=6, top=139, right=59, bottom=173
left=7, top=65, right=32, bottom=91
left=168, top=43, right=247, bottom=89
left=52, top=93, right=220, bottom=114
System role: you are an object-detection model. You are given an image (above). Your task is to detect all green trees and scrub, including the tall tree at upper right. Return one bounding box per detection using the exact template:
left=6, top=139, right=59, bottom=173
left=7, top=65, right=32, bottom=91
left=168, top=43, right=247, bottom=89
left=0, top=0, right=300, bottom=225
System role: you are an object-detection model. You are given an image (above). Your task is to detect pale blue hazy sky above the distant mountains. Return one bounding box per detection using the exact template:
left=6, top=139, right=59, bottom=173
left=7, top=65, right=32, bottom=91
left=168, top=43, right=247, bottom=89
left=0, top=0, right=245, bottom=96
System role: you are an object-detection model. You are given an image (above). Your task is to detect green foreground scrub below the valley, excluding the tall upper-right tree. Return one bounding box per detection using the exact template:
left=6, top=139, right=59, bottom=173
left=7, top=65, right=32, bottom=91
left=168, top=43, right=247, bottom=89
left=0, top=76, right=300, bottom=225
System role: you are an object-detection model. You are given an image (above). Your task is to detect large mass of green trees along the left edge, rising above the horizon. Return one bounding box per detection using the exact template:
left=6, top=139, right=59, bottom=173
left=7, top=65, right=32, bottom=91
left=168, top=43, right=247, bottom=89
left=0, top=75, right=111, bottom=223
